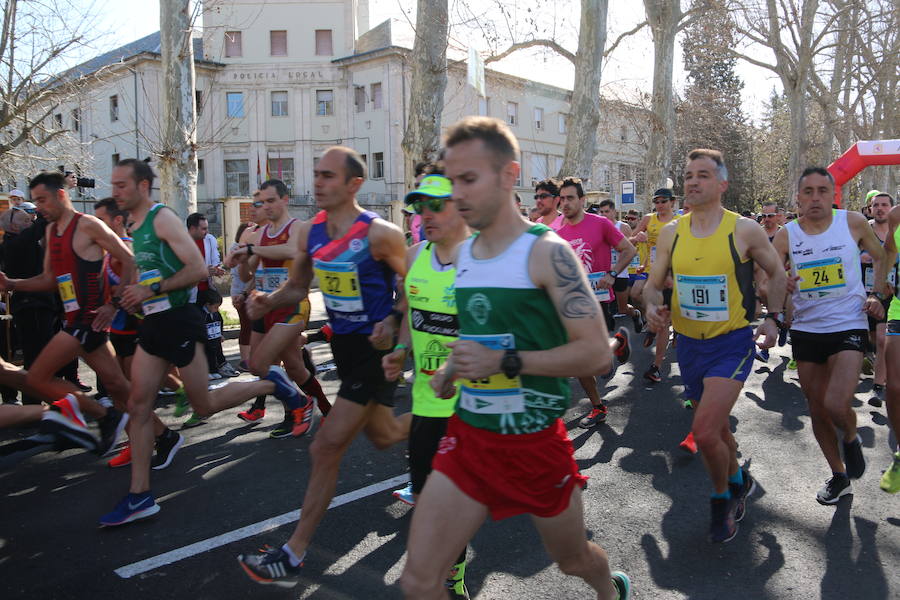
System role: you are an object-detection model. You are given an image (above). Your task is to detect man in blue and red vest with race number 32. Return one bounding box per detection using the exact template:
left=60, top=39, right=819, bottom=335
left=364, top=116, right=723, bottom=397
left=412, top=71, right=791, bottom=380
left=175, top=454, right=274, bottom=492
left=238, top=146, right=412, bottom=586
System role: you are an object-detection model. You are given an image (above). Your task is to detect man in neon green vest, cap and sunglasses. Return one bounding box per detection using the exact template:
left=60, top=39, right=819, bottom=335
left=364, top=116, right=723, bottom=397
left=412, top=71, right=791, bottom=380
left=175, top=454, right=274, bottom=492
left=382, top=175, right=469, bottom=599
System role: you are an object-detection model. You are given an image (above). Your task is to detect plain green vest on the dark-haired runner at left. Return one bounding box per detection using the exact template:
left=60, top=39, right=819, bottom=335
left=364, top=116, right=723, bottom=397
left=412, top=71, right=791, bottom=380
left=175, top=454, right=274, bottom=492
left=131, top=203, right=191, bottom=315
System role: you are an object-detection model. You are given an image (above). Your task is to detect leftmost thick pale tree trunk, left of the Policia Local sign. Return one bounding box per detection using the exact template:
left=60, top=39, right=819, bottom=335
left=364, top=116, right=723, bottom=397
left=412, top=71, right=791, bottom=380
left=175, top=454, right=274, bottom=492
left=159, top=0, right=197, bottom=218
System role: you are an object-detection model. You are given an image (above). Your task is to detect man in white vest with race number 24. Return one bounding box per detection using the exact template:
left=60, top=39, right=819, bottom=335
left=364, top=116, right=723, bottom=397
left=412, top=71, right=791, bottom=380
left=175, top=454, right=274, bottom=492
left=770, top=167, right=887, bottom=505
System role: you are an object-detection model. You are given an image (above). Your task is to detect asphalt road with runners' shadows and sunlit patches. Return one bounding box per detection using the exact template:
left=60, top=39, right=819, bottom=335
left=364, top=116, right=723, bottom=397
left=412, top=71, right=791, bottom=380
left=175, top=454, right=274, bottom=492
left=0, top=314, right=900, bottom=600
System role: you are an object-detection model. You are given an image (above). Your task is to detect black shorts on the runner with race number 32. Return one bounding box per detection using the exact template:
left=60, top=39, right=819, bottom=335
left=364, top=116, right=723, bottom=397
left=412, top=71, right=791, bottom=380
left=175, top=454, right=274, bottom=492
left=331, top=333, right=397, bottom=406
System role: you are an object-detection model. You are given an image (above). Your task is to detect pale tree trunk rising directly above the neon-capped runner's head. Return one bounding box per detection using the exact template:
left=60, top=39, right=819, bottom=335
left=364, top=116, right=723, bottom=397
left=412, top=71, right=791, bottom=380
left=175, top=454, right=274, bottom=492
left=401, top=0, right=448, bottom=189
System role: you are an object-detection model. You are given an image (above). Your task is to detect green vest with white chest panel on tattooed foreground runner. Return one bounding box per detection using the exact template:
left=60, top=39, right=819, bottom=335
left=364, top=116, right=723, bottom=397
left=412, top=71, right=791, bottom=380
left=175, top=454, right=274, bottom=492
left=456, top=225, right=569, bottom=434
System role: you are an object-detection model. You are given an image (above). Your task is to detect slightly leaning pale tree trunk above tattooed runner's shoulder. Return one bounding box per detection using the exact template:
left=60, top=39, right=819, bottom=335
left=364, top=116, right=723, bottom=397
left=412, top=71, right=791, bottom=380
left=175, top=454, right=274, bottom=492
left=560, top=0, right=608, bottom=181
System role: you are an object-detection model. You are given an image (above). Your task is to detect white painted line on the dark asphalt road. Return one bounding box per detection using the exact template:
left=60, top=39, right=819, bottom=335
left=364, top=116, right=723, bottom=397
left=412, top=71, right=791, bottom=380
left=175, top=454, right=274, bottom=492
left=115, top=473, right=409, bottom=579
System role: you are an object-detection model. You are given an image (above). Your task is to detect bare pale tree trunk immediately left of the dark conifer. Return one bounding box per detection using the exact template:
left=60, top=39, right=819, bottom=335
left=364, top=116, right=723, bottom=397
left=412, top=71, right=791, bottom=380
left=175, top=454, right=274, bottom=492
left=644, top=0, right=680, bottom=195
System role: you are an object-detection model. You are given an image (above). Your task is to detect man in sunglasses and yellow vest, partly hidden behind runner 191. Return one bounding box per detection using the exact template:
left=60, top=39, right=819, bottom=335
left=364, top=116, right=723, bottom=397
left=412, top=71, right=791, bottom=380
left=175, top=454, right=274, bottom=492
left=631, top=188, right=678, bottom=383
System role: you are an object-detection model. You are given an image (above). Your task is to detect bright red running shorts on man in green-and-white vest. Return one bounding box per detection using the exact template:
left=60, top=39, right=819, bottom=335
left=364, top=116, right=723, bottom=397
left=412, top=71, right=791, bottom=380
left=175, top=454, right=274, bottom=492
left=432, top=415, right=587, bottom=521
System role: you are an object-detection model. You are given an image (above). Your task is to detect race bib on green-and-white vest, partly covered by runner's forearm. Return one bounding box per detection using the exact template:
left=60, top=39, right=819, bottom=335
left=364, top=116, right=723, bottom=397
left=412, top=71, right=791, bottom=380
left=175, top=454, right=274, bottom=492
left=459, top=333, right=525, bottom=415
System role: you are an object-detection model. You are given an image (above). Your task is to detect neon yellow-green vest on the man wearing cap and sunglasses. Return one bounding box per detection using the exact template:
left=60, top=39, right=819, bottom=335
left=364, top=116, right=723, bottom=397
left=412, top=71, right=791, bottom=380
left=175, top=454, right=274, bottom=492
left=404, top=242, right=459, bottom=417
